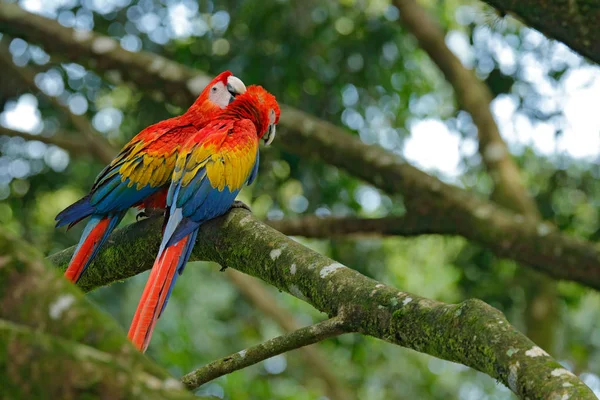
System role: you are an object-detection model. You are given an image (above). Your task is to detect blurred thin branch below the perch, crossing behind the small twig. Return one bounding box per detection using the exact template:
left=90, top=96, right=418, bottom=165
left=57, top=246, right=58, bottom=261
left=225, top=269, right=356, bottom=400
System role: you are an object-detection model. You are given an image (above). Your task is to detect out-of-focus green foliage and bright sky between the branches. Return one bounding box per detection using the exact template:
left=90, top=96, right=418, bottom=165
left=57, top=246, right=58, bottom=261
left=0, top=0, right=600, bottom=400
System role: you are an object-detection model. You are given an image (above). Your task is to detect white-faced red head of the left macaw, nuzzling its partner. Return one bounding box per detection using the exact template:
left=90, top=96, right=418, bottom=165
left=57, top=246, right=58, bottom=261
left=188, top=71, right=246, bottom=119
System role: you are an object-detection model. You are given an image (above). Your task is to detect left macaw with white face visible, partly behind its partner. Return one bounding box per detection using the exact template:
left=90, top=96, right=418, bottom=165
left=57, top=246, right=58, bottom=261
left=56, top=71, right=246, bottom=283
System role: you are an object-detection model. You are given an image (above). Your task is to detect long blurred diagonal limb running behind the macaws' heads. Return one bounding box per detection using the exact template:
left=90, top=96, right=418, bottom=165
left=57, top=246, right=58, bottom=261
left=0, top=3, right=600, bottom=288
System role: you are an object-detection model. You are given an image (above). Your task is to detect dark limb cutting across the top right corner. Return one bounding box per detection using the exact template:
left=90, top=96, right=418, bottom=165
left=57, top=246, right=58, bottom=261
left=482, top=0, right=600, bottom=64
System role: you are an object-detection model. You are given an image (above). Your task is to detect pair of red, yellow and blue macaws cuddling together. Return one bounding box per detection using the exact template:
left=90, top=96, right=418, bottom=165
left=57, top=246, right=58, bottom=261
left=56, top=71, right=279, bottom=352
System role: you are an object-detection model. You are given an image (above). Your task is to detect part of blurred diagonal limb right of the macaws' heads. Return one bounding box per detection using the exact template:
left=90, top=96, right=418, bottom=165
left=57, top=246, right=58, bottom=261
left=278, top=108, right=600, bottom=288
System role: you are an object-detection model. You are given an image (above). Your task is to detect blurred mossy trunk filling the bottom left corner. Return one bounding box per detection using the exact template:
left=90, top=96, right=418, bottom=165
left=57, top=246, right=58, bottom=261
left=0, top=230, right=202, bottom=399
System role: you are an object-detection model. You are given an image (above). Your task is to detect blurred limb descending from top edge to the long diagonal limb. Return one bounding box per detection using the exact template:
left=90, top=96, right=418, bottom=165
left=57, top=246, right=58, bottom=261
left=394, top=0, right=540, bottom=218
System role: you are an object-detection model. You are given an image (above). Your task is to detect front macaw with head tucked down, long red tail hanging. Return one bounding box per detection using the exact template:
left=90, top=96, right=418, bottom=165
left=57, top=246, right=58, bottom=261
left=129, top=86, right=279, bottom=352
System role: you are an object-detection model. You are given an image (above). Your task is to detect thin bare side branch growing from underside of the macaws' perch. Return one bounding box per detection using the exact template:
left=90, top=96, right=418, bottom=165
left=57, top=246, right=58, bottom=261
left=181, top=318, right=348, bottom=389
